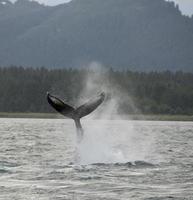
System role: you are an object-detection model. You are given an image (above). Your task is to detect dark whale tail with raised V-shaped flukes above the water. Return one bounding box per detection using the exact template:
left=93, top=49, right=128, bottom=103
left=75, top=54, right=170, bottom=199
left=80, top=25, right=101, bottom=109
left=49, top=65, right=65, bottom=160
left=47, top=92, right=105, bottom=140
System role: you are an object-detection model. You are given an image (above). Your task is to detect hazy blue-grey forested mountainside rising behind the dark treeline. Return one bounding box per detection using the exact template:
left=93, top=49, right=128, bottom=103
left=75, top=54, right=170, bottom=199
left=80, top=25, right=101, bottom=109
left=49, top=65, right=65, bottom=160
left=0, top=0, right=193, bottom=71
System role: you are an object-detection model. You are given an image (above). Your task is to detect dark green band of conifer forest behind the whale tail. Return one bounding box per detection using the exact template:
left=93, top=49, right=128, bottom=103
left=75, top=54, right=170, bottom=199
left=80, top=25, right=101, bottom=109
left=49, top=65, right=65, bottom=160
left=0, top=67, right=193, bottom=115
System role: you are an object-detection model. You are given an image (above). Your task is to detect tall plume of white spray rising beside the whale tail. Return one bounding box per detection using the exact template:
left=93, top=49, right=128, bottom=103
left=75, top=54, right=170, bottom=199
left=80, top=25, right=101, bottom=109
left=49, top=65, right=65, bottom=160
left=76, top=63, right=155, bottom=165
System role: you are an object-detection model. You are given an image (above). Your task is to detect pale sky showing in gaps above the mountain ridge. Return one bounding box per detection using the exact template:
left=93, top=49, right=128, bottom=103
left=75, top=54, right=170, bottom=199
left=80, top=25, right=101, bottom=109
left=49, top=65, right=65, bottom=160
left=12, top=0, right=193, bottom=16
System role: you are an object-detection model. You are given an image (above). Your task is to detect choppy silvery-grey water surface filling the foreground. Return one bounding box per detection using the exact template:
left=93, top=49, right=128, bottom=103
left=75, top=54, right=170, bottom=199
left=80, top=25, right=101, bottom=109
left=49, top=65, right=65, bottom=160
left=0, top=119, right=193, bottom=200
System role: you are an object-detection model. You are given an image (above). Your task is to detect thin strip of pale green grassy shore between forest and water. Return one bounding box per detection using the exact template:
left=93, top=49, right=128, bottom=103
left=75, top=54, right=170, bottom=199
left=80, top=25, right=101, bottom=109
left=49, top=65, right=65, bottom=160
left=0, top=112, right=193, bottom=121
